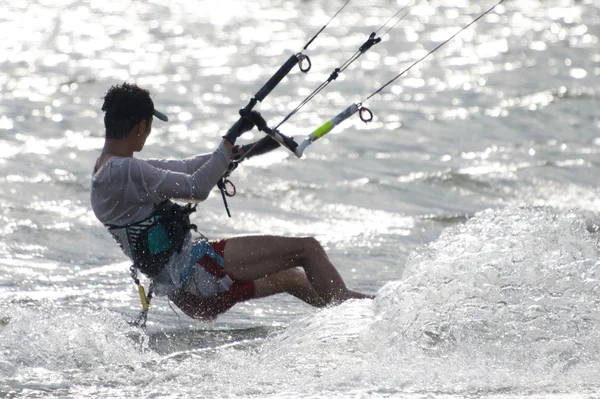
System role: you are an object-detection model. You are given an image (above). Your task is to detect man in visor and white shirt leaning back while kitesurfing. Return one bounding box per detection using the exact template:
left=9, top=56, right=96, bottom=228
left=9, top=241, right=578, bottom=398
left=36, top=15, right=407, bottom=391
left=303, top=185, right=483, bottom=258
left=91, top=83, right=372, bottom=319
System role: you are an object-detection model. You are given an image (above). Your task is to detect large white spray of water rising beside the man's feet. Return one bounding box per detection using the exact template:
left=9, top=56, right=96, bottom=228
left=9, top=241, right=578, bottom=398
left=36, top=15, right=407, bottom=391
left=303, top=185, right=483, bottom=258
left=255, top=209, right=600, bottom=394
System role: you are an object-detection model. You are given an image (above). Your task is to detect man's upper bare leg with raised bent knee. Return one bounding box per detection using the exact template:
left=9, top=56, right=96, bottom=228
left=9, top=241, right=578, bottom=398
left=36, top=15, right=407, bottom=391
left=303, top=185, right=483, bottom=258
left=224, top=236, right=373, bottom=304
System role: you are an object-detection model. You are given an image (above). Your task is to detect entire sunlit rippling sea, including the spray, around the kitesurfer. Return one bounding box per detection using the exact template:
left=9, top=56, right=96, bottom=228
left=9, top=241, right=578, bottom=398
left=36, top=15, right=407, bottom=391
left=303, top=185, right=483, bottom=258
left=0, top=0, right=600, bottom=398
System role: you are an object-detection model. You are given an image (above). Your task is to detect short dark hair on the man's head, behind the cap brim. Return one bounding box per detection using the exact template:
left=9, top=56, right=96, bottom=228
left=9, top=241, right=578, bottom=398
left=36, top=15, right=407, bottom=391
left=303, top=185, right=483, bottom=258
left=102, top=83, right=154, bottom=140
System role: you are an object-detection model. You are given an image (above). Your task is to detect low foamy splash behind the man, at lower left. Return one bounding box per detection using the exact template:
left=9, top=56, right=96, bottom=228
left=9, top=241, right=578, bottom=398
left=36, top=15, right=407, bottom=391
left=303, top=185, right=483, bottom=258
left=0, top=303, right=153, bottom=389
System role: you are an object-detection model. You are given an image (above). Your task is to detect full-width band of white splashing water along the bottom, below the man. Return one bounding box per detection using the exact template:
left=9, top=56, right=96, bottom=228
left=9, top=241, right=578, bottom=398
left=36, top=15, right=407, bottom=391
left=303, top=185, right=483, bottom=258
left=0, top=208, right=600, bottom=397
